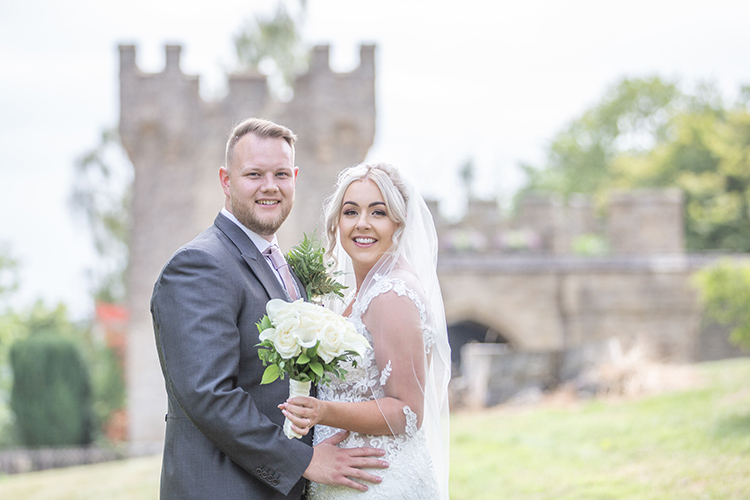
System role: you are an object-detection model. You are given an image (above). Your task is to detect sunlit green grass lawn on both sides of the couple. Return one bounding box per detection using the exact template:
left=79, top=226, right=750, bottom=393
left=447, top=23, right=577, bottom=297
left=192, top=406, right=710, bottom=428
left=0, top=358, right=750, bottom=500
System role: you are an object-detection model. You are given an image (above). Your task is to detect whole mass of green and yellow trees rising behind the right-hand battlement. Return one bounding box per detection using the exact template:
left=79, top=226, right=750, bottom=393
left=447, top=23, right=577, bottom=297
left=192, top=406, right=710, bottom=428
left=523, top=78, right=750, bottom=251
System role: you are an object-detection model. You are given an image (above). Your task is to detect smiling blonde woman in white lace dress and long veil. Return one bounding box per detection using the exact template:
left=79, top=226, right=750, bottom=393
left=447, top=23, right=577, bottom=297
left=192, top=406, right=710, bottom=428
left=281, top=163, right=450, bottom=500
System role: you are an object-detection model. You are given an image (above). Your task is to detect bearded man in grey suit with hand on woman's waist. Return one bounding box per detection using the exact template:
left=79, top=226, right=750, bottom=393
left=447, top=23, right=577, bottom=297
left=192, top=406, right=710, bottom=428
left=151, top=118, right=387, bottom=500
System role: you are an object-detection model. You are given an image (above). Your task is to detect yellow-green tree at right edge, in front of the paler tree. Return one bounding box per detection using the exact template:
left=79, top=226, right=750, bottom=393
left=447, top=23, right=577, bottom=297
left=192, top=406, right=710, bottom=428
left=636, top=101, right=750, bottom=252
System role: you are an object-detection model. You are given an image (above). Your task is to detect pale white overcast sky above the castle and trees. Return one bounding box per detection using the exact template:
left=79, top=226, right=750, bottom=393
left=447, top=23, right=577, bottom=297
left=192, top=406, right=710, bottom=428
left=0, top=0, right=750, bottom=316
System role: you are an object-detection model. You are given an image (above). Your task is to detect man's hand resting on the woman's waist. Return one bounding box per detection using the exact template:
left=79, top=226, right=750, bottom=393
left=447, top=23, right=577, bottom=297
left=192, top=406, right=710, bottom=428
left=303, top=431, right=388, bottom=491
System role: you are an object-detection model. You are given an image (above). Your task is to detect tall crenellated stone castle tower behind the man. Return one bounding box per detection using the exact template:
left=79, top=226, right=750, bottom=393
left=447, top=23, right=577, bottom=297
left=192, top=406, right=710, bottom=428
left=119, top=45, right=375, bottom=453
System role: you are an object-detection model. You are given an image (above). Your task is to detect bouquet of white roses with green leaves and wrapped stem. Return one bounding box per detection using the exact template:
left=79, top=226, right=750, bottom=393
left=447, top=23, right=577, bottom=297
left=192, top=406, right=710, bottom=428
left=257, top=299, right=370, bottom=439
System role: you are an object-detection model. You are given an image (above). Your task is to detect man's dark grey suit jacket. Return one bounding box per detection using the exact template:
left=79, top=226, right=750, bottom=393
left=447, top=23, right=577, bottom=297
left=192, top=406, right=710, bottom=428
left=151, top=214, right=313, bottom=500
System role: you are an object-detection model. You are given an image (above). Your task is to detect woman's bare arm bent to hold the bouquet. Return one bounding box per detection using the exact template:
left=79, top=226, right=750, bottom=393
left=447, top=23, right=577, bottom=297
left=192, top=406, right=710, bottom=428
left=281, top=291, right=425, bottom=435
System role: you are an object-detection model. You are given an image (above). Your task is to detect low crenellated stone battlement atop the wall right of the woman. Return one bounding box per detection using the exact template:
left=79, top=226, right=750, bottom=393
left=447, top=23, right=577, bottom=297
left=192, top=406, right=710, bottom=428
left=429, top=189, right=685, bottom=256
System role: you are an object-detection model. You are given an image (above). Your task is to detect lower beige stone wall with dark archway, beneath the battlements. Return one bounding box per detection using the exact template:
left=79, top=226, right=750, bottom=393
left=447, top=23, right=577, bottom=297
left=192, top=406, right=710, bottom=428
left=439, top=254, right=736, bottom=362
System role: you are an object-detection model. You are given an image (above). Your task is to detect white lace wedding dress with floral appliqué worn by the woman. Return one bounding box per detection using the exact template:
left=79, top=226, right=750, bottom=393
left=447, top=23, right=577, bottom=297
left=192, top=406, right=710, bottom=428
left=308, top=276, right=440, bottom=500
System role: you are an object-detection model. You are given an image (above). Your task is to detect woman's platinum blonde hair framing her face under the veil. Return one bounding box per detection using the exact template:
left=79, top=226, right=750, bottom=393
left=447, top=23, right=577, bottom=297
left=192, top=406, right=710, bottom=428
left=323, top=163, right=409, bottom=261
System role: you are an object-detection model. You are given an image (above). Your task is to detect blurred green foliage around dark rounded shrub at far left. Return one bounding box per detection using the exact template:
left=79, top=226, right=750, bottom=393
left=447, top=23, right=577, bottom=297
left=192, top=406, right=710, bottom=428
left=0, top=286, right=125, bottom=448
